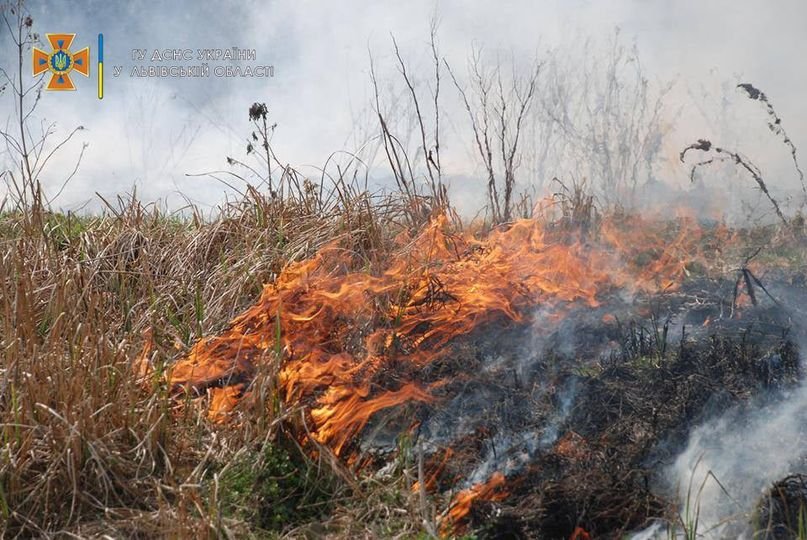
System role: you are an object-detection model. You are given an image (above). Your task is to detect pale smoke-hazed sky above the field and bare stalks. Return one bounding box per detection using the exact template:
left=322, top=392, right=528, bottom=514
left=0, top=0, right=807, bottom=215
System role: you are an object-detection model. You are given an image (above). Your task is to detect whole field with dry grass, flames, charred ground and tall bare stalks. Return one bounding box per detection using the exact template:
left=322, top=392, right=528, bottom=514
left=0, top=1, right=807, bottom=540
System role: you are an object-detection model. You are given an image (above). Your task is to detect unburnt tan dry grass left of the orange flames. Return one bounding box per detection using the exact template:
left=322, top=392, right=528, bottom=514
left=0, top=186, right=436, bottom=537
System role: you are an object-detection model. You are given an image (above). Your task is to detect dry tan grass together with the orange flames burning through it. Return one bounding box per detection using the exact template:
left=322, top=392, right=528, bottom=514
left=0, top=184, right=807, bottom=537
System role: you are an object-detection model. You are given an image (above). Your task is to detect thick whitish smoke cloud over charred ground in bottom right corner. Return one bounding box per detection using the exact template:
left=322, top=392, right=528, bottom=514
left=633, top=344, right=807, bottom=540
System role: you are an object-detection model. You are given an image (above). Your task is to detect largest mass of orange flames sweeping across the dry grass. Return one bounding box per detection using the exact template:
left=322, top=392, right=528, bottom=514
left=164, top=212, right=712, bottom=455
